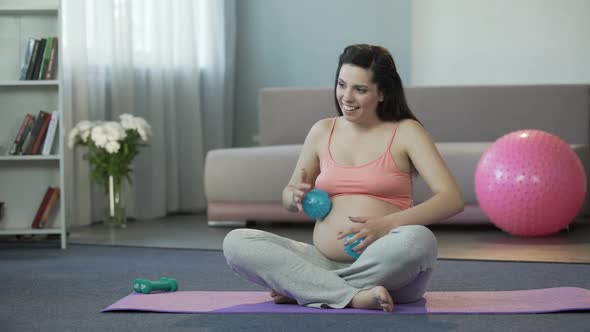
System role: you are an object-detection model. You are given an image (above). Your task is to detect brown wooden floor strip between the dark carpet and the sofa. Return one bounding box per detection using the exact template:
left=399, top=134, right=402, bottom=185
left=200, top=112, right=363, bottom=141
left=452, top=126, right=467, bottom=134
left=63, top=215, right=590, bottom=263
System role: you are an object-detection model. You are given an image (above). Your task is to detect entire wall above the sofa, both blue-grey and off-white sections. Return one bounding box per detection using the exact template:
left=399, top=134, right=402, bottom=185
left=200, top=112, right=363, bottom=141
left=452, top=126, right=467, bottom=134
left=234, top=0, right=590, bottom=146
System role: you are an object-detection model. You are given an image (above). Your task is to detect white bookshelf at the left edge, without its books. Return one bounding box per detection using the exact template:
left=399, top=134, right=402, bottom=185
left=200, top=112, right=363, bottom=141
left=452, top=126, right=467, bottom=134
left=0, top=0, right=67, bottom=249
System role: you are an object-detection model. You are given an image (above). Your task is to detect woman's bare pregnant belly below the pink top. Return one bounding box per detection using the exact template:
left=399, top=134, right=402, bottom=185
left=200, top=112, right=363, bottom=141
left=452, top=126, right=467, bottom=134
left=313, top=195, right=401, bottom=262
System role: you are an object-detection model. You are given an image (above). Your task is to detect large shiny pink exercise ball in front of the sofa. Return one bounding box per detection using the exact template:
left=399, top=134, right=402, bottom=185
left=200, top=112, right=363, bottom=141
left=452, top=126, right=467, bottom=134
left=475, top=129, right=586, bottom=236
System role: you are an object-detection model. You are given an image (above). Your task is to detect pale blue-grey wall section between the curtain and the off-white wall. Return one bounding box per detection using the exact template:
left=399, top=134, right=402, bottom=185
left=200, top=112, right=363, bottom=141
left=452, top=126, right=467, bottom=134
left=234, top=0, right=411, bottom=146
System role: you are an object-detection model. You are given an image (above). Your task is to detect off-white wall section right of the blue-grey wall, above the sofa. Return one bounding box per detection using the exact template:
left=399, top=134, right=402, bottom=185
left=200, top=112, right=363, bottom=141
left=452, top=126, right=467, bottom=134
left=410, top=0, right=590, bottom=85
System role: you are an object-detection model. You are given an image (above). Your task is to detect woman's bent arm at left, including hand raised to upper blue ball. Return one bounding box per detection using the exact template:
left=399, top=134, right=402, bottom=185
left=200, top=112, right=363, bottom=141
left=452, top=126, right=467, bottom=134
left=283, top=119, right=330, bottom=212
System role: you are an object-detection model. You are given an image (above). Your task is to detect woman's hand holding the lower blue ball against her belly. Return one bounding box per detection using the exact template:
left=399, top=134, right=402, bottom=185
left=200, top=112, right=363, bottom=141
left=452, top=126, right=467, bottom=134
left=338, top=217, right=391, bottom=253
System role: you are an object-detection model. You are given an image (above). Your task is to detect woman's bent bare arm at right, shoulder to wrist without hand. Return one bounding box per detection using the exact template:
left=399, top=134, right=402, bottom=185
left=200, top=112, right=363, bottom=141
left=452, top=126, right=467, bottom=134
left=384, top=120, right=465, bottom=229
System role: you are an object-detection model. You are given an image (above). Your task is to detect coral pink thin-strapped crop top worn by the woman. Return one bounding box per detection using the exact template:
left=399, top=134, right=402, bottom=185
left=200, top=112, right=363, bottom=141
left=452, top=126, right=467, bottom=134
left=315, top=118, right=413, bottom=209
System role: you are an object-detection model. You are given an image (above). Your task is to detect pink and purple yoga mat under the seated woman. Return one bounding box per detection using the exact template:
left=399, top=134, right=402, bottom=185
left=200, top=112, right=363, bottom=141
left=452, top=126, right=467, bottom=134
left=102, top=287, right=590, bottom=314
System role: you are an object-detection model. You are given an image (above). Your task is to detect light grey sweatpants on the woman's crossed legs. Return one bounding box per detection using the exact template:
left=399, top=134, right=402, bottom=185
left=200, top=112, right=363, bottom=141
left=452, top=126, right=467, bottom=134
left=223, top=225, right=437, bottom=308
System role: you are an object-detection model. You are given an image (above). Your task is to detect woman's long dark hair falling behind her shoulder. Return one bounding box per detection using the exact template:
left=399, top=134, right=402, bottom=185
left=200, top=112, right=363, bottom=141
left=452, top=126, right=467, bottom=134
left=334, top=44, right=420, bottom=122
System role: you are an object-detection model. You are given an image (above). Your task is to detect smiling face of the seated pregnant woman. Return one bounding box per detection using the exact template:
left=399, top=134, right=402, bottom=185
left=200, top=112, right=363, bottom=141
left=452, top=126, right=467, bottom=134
left=336, top=64, right=383, bottom=123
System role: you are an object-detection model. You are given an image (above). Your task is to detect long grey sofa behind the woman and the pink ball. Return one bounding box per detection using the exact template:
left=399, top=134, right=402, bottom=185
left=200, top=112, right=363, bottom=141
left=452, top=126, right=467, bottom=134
left=205, top=85, right=590, bottom=225
